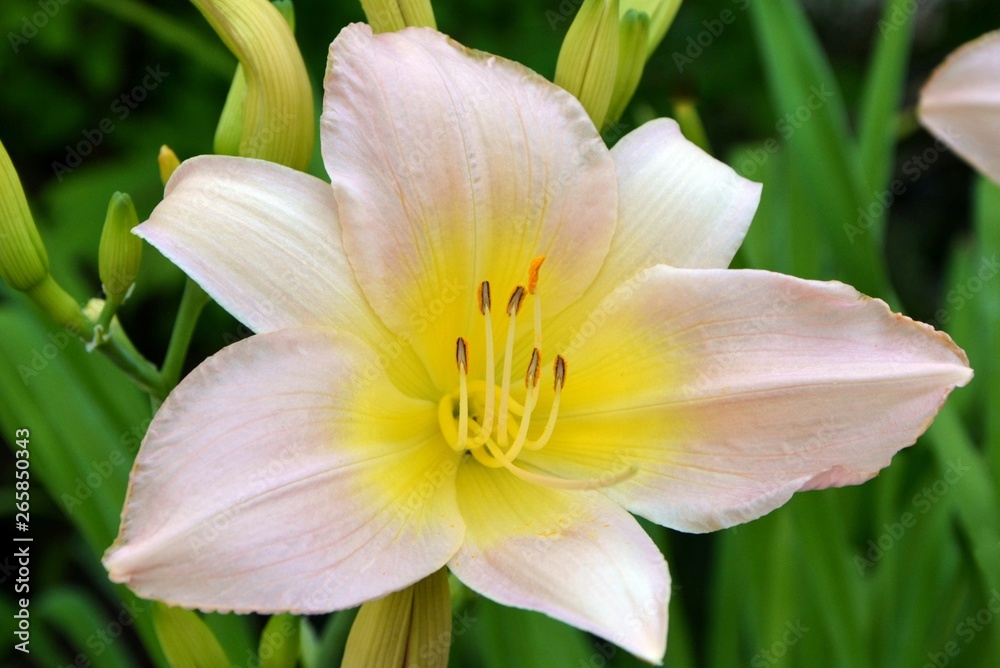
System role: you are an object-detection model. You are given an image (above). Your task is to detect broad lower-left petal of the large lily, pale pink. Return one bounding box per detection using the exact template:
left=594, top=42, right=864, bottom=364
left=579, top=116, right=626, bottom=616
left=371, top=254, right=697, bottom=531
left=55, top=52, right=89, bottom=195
left=104, top=328, right=464, bottom=613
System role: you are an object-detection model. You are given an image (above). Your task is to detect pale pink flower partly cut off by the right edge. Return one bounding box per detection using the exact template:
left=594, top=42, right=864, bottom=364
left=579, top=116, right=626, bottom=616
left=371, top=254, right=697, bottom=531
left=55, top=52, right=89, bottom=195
left=918, top=30, right=1000, bottom=183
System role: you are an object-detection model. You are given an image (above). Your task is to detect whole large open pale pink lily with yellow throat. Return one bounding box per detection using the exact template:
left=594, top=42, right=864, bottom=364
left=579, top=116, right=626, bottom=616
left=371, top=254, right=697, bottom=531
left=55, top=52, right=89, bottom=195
left=104, top=25, right=972, bottom=662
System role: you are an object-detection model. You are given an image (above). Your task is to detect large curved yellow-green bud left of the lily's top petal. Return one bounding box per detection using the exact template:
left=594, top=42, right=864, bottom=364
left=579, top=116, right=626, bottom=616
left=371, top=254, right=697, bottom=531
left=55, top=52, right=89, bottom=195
left=192, top=0, right=315, bottom=170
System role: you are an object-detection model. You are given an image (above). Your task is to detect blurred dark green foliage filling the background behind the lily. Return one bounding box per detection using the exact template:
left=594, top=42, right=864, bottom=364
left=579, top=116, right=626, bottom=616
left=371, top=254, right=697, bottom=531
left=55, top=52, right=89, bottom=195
left=0, top=0, right=1000, bottom=667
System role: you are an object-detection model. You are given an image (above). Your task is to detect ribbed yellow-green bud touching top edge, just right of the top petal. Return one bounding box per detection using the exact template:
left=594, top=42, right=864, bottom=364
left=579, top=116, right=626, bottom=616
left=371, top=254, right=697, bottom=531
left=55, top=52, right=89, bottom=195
left=555, top=0, right=621, bottom=129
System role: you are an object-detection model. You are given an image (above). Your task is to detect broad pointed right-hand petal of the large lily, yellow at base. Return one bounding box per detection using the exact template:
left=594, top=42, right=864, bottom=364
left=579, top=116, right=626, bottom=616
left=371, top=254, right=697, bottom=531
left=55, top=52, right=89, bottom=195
left=522, top=266, right=972, bottom=532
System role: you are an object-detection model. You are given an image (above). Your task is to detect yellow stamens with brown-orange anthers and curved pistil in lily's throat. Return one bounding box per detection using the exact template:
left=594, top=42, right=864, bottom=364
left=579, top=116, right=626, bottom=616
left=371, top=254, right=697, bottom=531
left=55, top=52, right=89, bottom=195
left=438, top=255, right=635, bottom=489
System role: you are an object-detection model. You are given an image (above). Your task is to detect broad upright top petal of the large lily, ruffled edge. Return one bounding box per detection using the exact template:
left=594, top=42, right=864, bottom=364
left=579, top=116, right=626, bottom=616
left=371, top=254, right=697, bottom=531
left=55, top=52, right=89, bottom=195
left=322, top=25, right=618, bottom=390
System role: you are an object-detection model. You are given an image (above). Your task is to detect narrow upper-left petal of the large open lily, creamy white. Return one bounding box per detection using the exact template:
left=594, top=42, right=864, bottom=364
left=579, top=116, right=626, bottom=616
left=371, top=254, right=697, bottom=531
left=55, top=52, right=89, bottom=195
left=135, top=156, right=428, bottom=396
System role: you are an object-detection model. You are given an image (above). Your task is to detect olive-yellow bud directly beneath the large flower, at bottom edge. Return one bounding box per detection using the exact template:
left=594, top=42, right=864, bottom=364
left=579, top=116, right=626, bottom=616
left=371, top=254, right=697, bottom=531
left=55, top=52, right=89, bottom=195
left=341, top=569, right=451, bottom=668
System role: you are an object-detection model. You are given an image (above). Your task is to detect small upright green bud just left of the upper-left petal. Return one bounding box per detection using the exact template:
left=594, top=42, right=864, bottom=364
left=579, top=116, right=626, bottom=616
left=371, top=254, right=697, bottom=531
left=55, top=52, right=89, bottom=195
left=97, top=193, right=142, bottom=305
